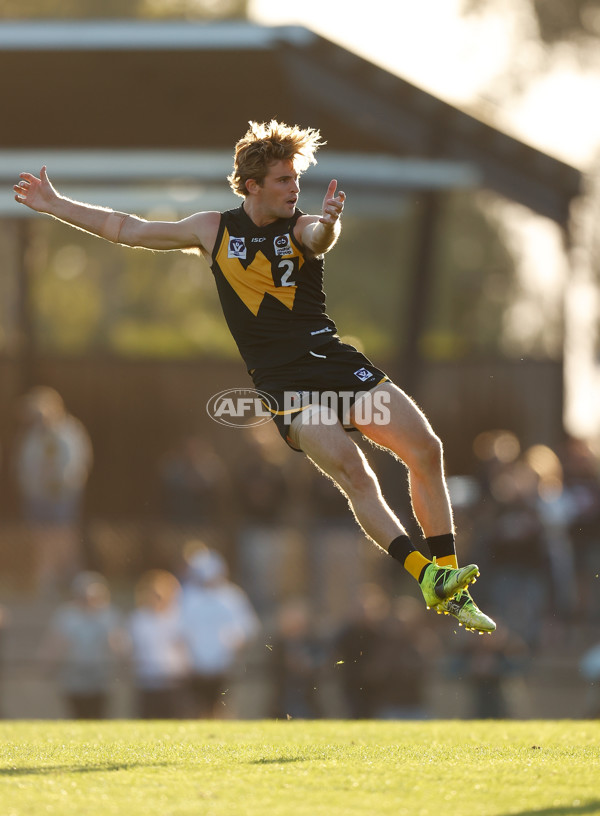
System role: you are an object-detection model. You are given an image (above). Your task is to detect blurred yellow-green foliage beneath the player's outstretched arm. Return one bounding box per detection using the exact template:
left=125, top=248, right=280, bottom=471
left=31, top=220, right=236, bottom=358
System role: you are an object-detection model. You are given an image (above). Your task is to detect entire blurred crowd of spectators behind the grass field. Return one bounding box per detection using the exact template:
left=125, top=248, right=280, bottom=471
left=0, top=388, right=600, bottom=719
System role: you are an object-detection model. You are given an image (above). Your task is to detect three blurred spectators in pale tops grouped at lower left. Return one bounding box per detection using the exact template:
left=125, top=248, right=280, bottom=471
left=39, top=544, right=260, bottom=719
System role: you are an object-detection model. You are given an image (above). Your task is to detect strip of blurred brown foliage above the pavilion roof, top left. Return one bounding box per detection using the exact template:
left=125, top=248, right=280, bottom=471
left=0, top=0, right=248, bottom=20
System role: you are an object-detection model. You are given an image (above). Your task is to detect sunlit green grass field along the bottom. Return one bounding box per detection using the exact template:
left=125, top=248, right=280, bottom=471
left=0, top=721, right=600, bottom=816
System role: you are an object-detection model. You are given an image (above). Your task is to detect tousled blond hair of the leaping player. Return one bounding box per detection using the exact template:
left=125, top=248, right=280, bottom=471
left=227, top=119, right=326, bottom=198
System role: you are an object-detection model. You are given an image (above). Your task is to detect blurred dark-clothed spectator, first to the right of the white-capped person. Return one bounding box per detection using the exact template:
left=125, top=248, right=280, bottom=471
left=269, top=598, right=325, bottom=719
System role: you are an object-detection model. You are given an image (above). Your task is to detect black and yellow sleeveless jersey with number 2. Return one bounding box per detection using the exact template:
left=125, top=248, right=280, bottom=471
left=211, top=207, right=337, bottom=370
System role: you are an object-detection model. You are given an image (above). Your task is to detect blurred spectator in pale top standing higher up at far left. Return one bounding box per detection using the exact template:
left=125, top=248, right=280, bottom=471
left=16, top=386, right=92, bottom=595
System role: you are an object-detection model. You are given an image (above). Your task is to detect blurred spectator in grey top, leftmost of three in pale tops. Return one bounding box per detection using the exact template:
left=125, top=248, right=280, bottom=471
left=40, top=572, right=123, bottom=720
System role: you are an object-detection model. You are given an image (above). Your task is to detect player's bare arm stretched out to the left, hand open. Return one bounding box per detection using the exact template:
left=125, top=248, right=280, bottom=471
left=13, top=167, right=220, bottom=253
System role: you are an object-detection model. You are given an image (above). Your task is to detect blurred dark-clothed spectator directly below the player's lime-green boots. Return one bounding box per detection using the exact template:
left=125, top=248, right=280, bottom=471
left=451, top=621, right=528, bottom=719
